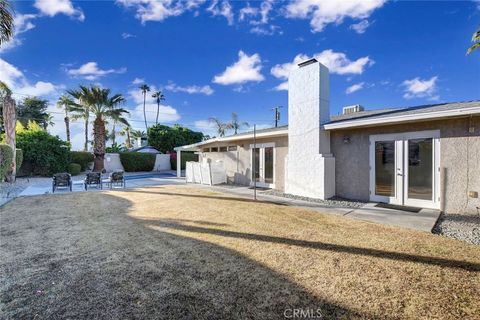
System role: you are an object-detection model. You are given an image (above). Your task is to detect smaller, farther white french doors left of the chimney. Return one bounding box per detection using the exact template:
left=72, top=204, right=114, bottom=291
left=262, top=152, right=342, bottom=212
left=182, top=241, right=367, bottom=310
left=250, top=143, right=275, bottom=188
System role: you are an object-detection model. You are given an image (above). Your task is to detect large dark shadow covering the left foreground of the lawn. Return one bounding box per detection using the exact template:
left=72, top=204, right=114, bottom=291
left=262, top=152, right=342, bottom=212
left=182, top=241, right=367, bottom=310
left=0, top=194, right=374, bottom=319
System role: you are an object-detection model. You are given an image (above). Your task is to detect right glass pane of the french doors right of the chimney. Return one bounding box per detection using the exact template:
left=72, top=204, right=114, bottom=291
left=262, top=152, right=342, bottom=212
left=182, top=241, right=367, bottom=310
left=408, top=138, right=433, bottom=200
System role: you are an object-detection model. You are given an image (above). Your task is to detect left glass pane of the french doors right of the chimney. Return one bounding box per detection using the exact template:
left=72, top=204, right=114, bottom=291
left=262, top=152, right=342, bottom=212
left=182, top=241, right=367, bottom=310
left=375, top=141, right=395, bottom=197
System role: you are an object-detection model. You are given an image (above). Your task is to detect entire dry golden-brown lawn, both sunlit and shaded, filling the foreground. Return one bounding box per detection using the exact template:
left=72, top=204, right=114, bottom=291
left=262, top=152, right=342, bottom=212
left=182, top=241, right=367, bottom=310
left=0, top=186, right=480, bottom=319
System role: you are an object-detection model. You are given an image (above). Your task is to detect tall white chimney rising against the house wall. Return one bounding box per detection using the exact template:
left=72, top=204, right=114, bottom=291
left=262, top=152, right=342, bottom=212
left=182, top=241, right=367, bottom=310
left=285, top=59, right=335, bottom=199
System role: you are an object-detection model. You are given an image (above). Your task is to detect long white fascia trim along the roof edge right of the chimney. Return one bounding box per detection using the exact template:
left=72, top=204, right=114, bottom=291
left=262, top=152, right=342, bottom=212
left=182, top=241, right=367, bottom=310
left=324, top=107, right=480, bottom=130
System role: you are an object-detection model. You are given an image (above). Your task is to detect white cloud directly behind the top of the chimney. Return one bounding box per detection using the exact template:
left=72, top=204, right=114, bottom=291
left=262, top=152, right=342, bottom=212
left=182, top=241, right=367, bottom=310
left=270, top=49, right=374, bottom=90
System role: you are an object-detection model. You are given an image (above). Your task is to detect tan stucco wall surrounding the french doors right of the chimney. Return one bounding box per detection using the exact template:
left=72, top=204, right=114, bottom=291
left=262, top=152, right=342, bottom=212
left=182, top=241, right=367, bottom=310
left=330, top=116, right=480, bottom=214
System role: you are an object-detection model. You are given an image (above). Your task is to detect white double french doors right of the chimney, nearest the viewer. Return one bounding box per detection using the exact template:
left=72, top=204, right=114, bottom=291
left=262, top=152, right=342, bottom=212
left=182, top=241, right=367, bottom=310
left=369, top=130, right=440, bottom=209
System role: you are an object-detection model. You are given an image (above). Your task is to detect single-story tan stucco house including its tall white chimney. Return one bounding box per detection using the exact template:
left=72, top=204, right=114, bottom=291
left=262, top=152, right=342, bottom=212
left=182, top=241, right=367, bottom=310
left=176, top=59, right=480, bottom=214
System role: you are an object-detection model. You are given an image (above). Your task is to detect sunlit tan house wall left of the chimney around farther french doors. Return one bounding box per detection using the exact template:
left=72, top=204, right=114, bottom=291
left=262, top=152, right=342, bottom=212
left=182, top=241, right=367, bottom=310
left=199, top=136, right=288, bottom=191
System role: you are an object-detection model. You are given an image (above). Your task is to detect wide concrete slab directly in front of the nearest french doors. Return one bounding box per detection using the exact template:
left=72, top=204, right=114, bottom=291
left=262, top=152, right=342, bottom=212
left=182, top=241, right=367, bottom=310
left=346, top=203, right=440, bottom=232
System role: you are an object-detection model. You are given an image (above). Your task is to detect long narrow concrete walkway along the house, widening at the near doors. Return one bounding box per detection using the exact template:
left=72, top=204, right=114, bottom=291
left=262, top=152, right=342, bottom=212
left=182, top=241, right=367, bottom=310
left=194, top=185, right=440, bottom=232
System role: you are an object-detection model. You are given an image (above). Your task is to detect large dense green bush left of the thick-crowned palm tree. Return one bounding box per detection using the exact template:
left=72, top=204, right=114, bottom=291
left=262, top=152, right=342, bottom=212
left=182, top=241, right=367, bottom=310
left=17, top=130, right=70, bottom=176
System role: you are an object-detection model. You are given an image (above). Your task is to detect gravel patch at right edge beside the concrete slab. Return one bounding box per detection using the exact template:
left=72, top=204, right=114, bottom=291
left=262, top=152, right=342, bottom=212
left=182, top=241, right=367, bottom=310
left=432, top=213, right=480, bottom=245
